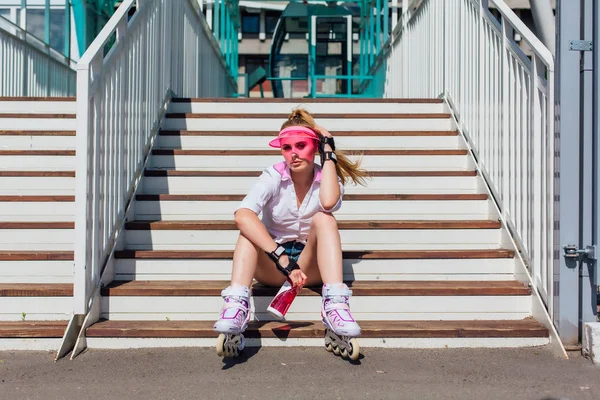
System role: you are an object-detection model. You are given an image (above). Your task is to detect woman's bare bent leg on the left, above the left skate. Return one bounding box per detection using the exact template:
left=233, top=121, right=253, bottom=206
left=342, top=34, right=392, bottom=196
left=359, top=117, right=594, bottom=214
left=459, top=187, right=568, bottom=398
left=231, top=234, right=285, bottom=287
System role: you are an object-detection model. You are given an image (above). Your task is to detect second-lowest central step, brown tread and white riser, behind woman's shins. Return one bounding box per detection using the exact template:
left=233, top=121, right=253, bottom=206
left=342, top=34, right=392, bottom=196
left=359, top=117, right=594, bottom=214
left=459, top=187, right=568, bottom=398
left=100, top=279, right=531, bottom=321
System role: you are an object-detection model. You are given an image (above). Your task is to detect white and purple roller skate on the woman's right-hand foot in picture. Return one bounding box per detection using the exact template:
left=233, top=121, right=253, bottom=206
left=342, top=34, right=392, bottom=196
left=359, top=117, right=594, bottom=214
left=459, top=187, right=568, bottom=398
left=321, top=283, right=360, bottom=360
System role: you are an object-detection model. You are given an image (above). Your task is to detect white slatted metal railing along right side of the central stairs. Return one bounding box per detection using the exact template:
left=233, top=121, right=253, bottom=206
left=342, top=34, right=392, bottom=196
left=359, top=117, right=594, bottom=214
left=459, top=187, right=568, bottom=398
left=376, top=0, right=554, bottom=315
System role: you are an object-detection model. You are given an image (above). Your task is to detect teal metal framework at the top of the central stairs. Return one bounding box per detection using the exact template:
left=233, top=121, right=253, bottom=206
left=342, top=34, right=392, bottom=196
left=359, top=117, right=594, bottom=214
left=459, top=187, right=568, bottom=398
left=253, top=0, right=389, bottom=98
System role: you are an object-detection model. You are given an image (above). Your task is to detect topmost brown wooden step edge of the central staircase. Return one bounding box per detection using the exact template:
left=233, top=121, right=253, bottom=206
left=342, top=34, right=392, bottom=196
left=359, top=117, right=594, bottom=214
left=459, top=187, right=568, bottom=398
left=171, top=97, right=444, bottom=104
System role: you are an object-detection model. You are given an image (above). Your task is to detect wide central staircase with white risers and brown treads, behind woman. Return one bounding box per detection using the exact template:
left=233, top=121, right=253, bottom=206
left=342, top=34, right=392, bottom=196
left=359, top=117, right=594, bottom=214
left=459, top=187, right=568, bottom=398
left=81, top=99, right=550, bottom=348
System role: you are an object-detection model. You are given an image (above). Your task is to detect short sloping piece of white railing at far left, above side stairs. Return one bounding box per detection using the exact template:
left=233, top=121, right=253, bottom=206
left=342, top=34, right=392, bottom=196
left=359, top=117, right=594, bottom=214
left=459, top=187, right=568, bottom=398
left=0, top=17, right=76, bottom=97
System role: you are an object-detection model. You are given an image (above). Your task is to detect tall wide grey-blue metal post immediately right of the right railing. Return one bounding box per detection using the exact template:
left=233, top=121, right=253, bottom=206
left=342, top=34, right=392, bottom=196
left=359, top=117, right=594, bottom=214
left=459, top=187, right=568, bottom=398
left=553, top=0, right=581, bottom=345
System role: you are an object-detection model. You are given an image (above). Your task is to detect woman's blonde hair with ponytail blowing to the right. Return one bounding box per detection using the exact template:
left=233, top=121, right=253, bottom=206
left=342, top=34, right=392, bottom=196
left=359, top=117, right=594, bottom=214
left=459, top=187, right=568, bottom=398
left=281, top=108, right=369, bottom=186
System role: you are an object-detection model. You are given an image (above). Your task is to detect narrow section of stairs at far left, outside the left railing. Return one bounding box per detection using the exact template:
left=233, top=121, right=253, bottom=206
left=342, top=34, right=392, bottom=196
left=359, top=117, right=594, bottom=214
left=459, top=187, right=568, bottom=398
left=0, top=98, right=75, bottom=350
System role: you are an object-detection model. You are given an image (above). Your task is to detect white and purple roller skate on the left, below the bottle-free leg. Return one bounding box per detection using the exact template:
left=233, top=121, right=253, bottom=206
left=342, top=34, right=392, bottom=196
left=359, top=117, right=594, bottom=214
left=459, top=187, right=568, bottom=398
left=213, top=286, right=250, bottom=357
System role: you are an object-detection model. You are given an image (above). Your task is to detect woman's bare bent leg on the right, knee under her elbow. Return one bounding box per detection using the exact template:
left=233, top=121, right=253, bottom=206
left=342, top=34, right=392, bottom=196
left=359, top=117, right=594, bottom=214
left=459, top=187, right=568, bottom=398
left=298, top=212, right=343, bottom=286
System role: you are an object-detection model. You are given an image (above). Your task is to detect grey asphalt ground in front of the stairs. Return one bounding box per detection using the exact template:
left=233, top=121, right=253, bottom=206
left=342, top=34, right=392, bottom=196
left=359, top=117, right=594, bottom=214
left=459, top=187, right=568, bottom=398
left=0, top=347, right=600, bottom=400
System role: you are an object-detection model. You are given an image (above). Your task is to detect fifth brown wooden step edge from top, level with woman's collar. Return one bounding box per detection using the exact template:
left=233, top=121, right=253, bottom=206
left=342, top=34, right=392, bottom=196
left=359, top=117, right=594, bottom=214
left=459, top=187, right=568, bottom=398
left=143, top=169, right=477, bottom=178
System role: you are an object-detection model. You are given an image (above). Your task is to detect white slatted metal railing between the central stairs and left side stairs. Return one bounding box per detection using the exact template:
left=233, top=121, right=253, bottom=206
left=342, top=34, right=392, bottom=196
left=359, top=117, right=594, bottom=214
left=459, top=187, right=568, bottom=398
left=74, top=0, right=236, bottom=314
